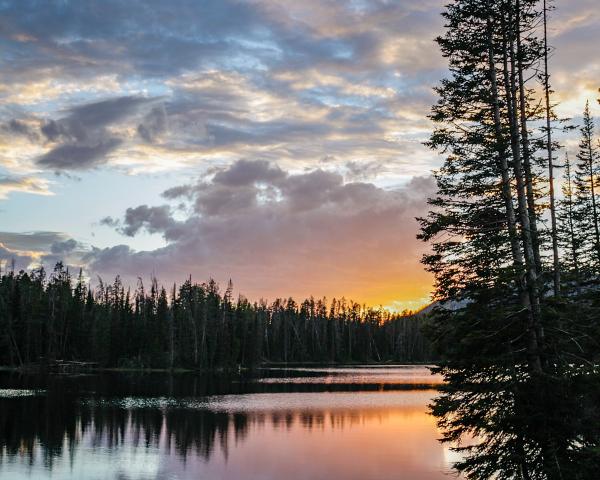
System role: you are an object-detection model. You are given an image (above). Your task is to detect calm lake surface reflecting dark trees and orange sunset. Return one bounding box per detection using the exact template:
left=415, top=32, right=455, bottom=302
left=0, top=366, right=456, bottom=480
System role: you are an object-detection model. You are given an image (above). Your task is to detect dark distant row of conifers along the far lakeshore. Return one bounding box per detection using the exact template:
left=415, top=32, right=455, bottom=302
left=0, top=263, right=432, bottom=369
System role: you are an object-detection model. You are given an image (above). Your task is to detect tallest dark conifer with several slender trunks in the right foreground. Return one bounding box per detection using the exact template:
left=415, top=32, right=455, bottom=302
left=420, top=0, right=596, bottom=480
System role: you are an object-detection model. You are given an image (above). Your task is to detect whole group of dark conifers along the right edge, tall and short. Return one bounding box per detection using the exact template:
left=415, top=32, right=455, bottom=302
left=420, top=0, right=600, bottom=480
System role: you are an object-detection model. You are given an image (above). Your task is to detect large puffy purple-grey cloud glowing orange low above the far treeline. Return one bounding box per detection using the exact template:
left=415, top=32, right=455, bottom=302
left=91, top=161, right=434, bottom=303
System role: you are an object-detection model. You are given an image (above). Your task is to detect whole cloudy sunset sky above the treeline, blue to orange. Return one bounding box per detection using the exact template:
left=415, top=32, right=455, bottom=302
left=0, top=0, right=600, bottom=310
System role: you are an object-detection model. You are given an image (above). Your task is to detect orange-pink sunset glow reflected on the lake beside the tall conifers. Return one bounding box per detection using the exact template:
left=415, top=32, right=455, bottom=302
left=171, top=392, right=460, bottom=480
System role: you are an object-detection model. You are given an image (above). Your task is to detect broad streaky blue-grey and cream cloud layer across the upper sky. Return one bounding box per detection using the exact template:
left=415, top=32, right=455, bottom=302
left=0, top=0, right=450, bottom=178
